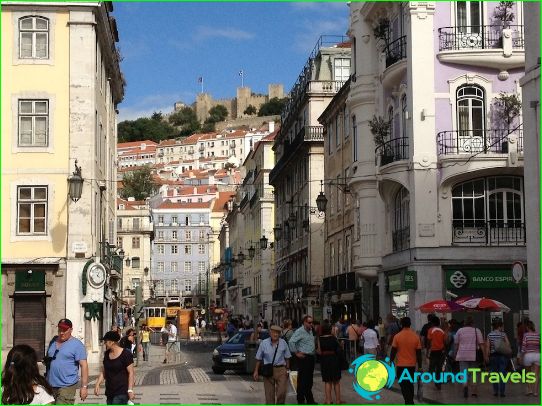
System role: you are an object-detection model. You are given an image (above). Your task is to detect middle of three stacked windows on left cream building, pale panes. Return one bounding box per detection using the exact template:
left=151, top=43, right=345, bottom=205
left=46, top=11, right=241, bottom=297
left=18, top=100, right=49, bottom=147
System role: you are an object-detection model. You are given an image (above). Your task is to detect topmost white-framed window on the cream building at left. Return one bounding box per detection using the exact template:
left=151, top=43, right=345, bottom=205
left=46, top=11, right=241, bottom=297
left=19, top=16, right=49, bottom=59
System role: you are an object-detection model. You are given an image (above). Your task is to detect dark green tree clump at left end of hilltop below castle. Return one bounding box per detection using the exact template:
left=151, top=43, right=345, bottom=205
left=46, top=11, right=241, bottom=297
left=117, top=113, right=178, bottom=142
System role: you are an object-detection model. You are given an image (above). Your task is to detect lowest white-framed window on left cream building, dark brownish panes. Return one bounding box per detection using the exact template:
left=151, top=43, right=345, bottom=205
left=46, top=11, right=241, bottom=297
left=17, top=186, right=47, bottom=235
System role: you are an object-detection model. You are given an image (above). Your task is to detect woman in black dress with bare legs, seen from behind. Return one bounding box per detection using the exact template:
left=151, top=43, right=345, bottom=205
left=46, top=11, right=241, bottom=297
left=317, top=323, right=343, bottom=404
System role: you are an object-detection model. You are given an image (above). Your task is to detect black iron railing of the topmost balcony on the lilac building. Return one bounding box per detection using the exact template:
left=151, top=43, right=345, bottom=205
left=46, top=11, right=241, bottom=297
left=438, top=25, right=525, bottom=51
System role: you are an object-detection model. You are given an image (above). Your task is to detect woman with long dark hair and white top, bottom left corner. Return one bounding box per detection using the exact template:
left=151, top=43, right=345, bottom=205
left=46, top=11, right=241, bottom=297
left=2, top=344, right=55, bottom=405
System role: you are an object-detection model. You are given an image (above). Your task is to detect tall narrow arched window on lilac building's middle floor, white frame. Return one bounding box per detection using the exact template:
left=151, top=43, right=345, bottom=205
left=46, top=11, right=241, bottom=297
left=456, top=85, right=485, bottom=153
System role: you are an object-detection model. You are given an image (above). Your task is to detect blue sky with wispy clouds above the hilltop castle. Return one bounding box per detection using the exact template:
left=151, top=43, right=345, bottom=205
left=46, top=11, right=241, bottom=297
left=113, top=2, right=348, bottom=122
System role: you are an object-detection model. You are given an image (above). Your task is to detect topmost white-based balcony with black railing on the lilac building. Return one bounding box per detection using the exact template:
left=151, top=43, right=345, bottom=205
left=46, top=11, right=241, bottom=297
left=438, top=25, right=525, bottom=71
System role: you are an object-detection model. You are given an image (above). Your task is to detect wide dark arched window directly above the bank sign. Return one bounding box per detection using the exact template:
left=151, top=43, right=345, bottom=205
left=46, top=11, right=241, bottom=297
left=452, top=176, right=525, bottom=245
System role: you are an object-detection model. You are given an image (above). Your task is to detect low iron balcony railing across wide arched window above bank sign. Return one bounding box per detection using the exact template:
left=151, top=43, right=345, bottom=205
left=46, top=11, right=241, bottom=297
left=452, top=221, right=526, bottom=247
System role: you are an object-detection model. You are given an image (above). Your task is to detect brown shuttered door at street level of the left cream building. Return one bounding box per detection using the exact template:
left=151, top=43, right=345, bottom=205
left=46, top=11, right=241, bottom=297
left=13, top=294, right=45, bottom=359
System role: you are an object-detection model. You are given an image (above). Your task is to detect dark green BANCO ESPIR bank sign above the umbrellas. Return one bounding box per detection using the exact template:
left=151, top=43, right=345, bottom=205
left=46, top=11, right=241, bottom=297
left=446, top=269, right=527, bottom=289
